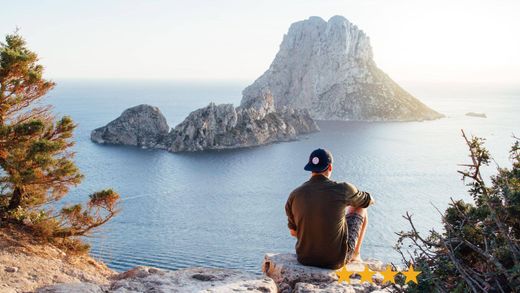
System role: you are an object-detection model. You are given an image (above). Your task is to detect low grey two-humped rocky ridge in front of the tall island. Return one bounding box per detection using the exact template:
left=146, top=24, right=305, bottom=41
left=91, top=92, right=319, bottom=152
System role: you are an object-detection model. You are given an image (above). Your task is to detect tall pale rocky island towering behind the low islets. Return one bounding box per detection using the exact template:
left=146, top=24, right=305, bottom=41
left=242, top=16, right=441, bottom=121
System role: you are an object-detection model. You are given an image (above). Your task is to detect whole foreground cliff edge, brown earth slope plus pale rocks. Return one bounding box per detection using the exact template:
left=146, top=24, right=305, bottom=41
left=0, top=228, right=390, bottom=293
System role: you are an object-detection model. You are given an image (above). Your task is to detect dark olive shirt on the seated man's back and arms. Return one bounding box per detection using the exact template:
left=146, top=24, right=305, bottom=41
left=285, top=175, right=370, bottom=269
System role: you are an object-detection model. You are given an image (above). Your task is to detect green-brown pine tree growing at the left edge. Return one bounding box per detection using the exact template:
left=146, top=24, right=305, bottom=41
left=0, top=33, right=119, bottom=248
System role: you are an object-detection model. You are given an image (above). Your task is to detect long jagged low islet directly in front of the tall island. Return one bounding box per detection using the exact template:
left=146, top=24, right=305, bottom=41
left=166, top=93, right=318, bottom=152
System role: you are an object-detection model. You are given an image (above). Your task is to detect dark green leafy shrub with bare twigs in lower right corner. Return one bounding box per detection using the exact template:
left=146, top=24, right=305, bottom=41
left=396, top=132, right=520, bottom=292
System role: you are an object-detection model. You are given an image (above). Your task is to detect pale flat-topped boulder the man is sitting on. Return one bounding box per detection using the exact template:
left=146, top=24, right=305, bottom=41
left=262, top=253, right=394, bottom=292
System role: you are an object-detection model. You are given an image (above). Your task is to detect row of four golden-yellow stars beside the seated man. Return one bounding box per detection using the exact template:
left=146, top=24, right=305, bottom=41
left=336, top=265, right=421, bottom=284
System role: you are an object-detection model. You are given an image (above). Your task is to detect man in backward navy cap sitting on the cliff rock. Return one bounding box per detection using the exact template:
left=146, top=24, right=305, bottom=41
left=285, top=149, right=374, bottom=269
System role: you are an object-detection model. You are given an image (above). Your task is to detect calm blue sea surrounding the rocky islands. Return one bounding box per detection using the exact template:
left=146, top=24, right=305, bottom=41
left=46, top=80, right=520, bottom=273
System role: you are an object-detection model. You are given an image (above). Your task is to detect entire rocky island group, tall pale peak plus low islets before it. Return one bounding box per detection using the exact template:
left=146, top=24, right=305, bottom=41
left=91, top=16, right=442, bottom=152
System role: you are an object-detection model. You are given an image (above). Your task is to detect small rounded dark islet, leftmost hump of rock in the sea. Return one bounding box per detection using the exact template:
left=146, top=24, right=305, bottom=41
left=90, top=105, right=170, bottom=148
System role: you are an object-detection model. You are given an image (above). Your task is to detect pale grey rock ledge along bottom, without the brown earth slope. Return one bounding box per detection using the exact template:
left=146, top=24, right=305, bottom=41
left=30, top=254, right=392, bottom=293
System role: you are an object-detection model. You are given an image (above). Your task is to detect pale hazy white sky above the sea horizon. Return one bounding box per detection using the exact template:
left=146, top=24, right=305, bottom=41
left=0, top=0, right=520, bottom=84
